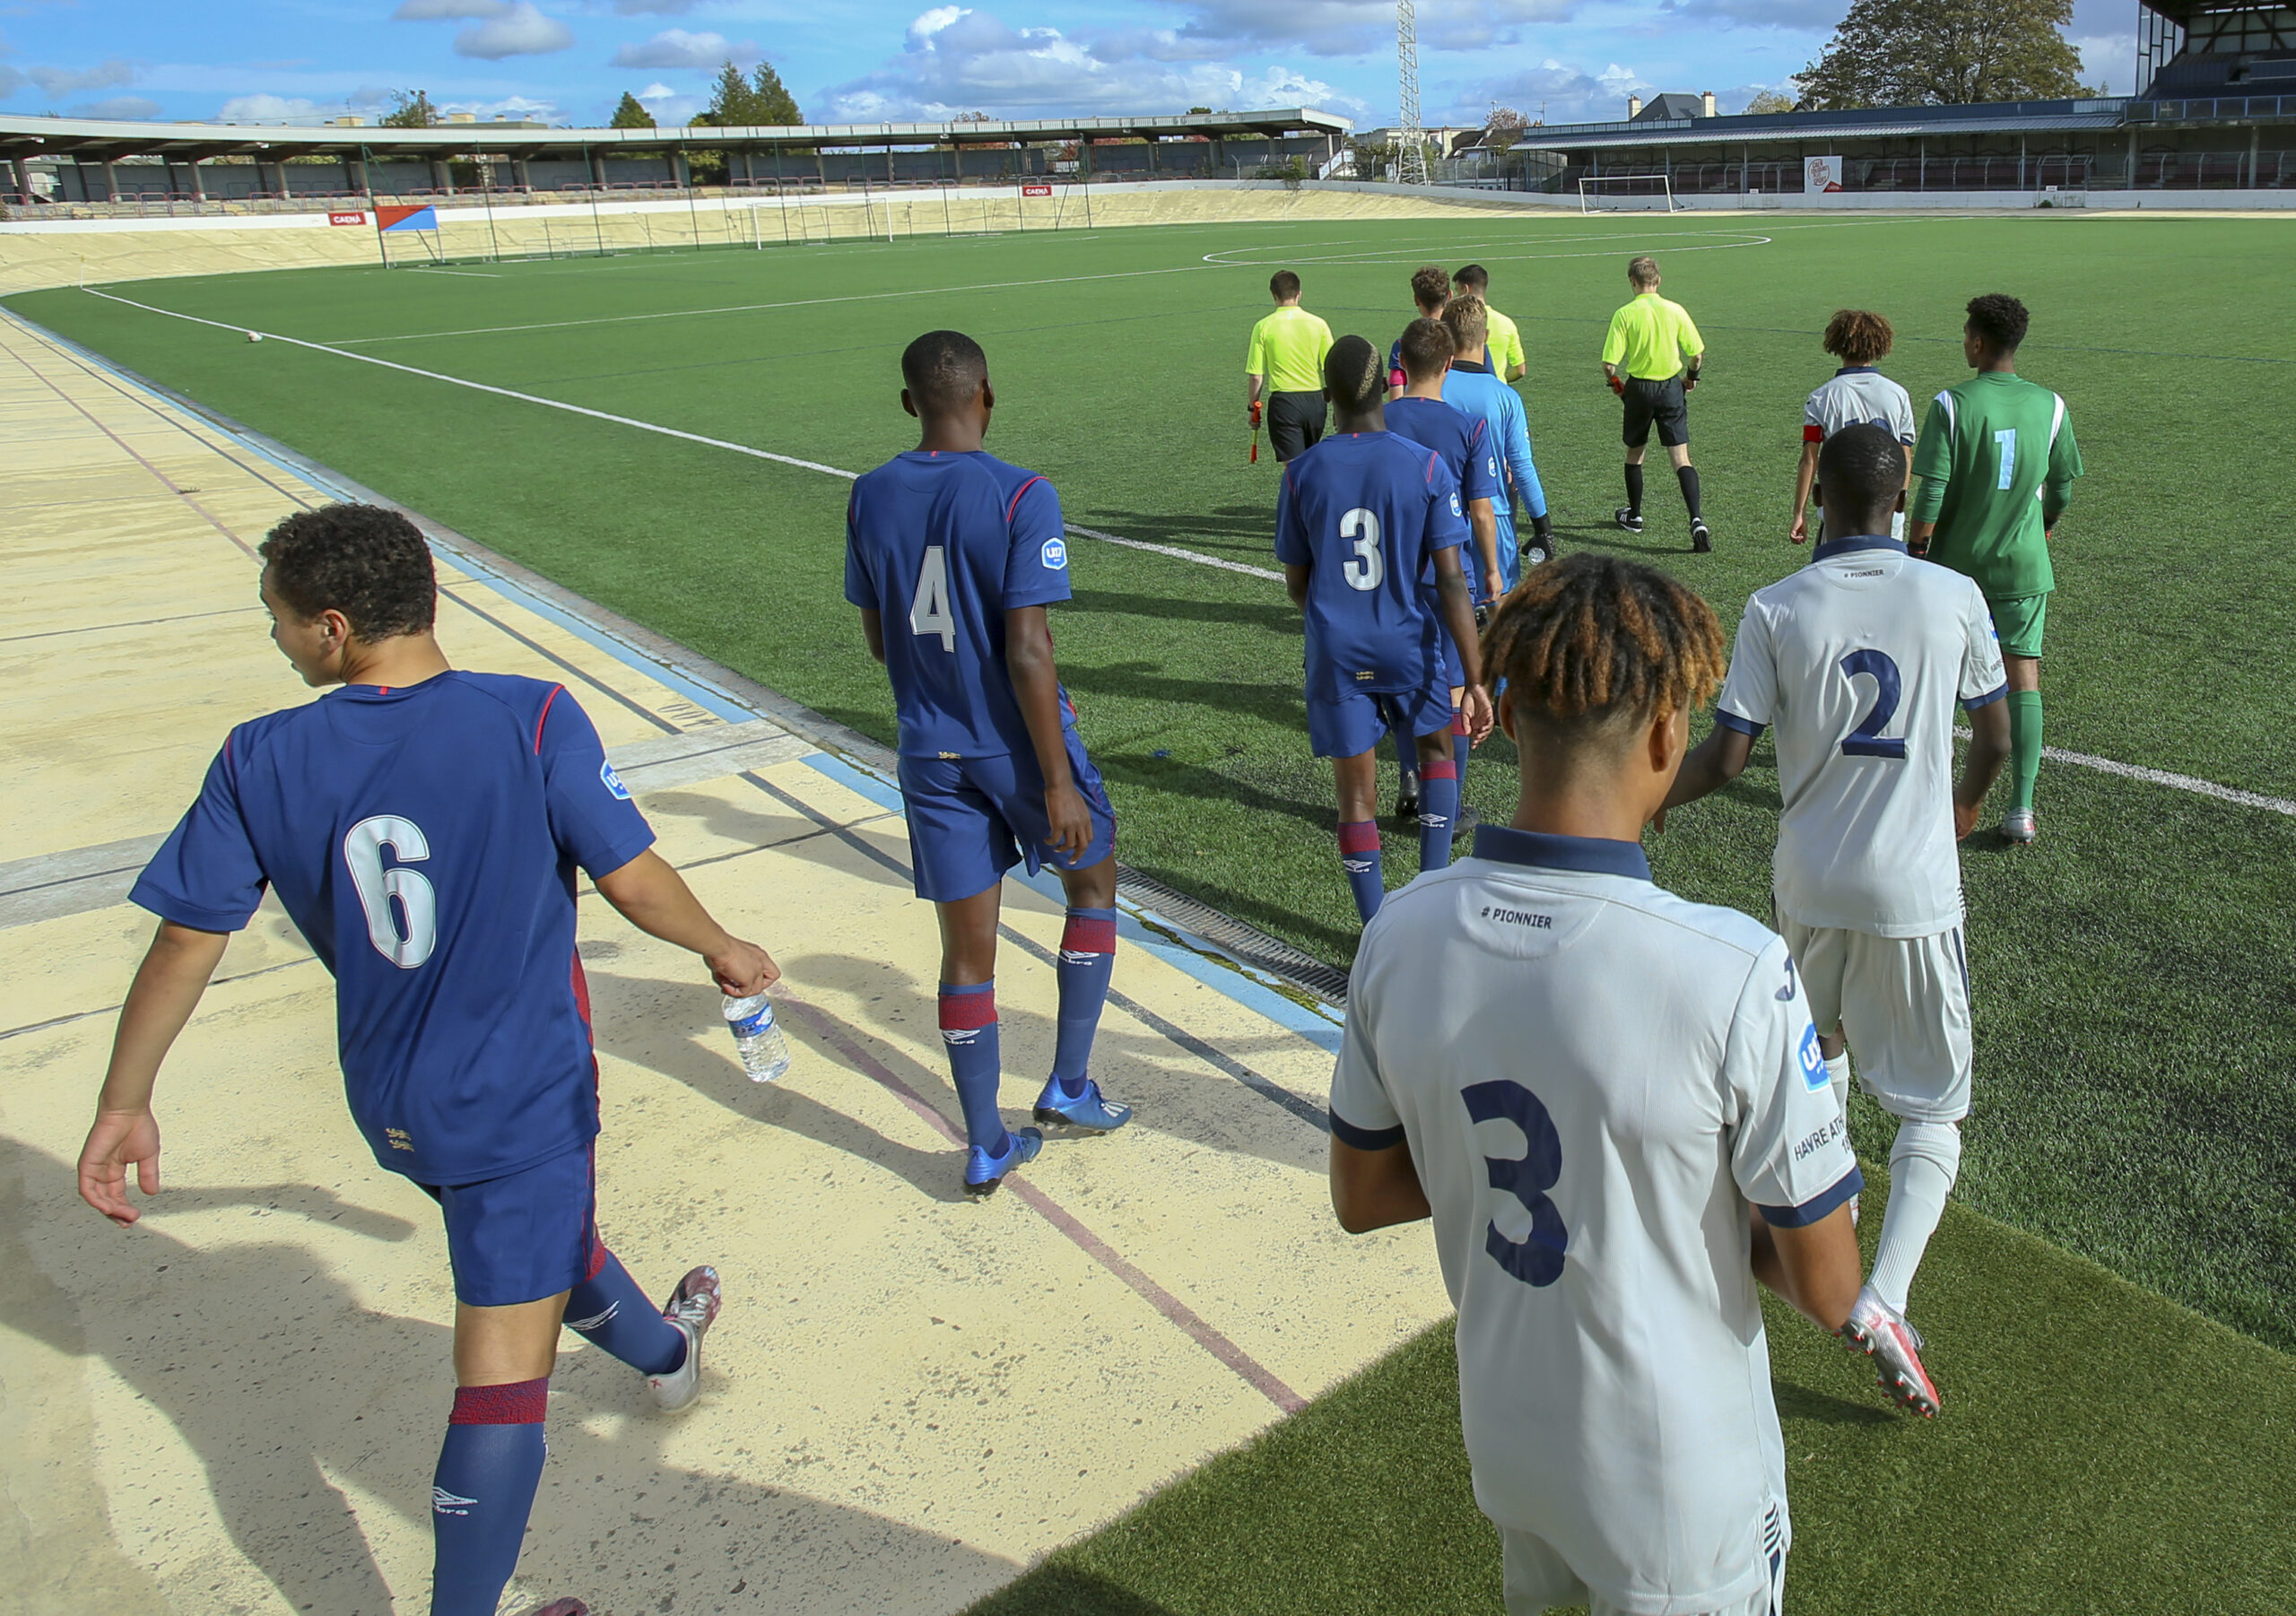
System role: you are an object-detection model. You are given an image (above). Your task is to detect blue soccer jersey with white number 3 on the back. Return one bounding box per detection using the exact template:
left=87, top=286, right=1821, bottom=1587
left=1276, top=431, right=1467, bottom=702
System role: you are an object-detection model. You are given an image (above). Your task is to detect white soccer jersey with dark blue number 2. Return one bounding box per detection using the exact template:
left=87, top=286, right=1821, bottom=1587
left=1715, top=537, right=2009, bottom=936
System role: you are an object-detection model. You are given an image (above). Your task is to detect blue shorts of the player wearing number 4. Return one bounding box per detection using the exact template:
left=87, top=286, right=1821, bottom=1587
left=900, top=723, right=1116, bottom=905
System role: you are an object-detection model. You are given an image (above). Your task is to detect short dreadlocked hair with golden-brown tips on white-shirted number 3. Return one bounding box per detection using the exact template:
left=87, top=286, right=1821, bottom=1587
left=1483, top=551, right=1729, bottom=737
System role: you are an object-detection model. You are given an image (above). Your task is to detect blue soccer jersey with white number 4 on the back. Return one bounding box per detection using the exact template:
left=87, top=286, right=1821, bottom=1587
left=845, top=450, right=1067, bottom=758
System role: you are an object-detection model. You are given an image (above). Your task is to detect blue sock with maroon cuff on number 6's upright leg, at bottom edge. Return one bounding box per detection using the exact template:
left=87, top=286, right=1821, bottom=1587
left=431, top=1375, right=551, bottom=1616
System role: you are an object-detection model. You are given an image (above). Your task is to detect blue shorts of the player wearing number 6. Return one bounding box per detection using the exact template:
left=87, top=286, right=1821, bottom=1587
left=422, top=1145, right=597, bottom=1308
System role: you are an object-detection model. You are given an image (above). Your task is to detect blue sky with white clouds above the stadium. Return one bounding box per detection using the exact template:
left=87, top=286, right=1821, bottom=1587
left=0, top=0, right=2133, bottom=126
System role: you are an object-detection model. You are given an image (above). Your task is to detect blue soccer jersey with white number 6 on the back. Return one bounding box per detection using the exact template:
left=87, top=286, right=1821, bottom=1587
left=131, top=673, right=655, bottom=1185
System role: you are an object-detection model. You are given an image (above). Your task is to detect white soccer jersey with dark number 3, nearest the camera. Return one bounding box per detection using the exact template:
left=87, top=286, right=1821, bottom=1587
left=1332, top=826, right=1860, bottom=1616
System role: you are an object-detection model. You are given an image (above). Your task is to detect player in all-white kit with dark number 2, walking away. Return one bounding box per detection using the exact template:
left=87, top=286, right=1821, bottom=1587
left=1667, top=422, right=2009, bottom=1416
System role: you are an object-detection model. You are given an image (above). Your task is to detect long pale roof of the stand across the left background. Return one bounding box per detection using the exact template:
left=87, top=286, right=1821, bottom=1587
left=0, top=108, right=1354, bottom=163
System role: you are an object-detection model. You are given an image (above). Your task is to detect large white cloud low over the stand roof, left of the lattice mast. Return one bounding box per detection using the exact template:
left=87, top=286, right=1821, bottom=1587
left=822, top=4, right=1361, bottom=122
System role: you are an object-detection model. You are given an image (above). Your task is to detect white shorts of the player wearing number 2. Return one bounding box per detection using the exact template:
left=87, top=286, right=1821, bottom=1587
left=1777, top=916, right=1970, bottom=1123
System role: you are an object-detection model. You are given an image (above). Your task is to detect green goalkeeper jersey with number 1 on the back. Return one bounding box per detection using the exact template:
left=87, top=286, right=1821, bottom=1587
left=1912, top=369, right=2080, bottom=602
